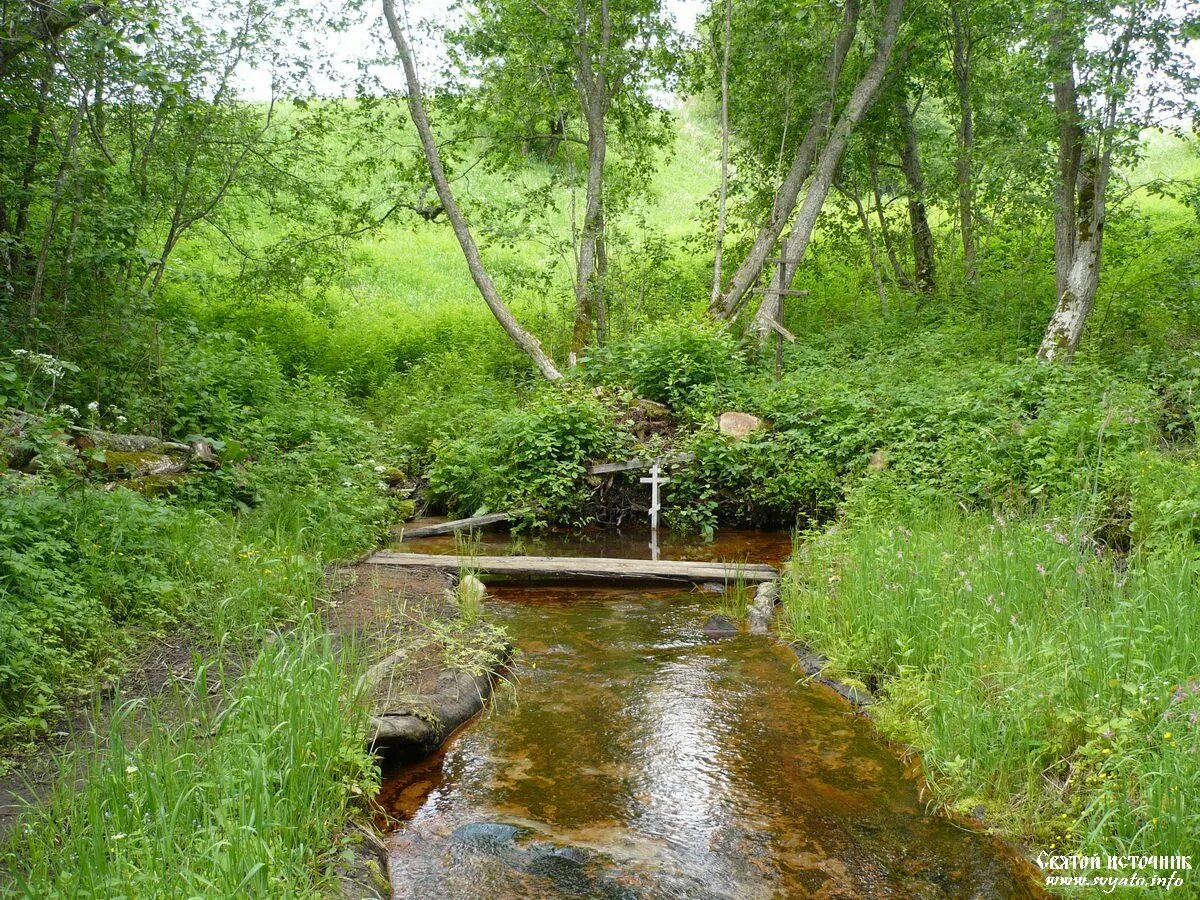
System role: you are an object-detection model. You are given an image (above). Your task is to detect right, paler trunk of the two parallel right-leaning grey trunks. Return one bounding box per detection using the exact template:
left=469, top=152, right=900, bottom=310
left=751, top=0, right=904, bottom=343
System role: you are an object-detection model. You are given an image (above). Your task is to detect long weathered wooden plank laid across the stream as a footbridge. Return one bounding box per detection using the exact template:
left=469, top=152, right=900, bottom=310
left=367, top=550, right=779, bottom=583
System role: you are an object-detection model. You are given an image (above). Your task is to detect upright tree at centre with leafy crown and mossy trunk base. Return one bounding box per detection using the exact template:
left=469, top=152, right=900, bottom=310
left=448, top=0, right=674, bottom=358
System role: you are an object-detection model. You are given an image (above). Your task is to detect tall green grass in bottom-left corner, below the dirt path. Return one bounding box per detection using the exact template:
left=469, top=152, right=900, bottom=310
left=0, top=619, right=377, bottom=899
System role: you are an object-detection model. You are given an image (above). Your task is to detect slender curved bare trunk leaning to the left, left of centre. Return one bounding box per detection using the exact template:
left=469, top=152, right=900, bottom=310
left=383, top=0, right=563, bottom=380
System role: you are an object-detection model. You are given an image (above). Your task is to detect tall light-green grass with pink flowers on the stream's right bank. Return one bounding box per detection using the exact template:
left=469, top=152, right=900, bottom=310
left=785, top=510, right=1200, bottom=854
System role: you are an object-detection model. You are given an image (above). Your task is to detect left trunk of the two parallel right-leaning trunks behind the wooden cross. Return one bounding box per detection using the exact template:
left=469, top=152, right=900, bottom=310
left=709, top=0, right=859, bottom=319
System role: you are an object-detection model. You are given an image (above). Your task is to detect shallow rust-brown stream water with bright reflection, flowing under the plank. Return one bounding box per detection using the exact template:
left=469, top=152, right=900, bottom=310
left=383, top=533, right=1037, bottom=900
